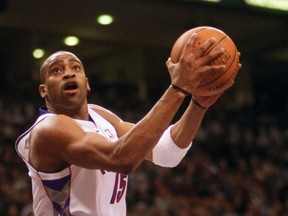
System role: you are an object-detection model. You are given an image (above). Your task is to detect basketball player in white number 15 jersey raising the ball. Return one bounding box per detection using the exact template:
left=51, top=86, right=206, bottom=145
left=16, top=34, right=241, bottom=216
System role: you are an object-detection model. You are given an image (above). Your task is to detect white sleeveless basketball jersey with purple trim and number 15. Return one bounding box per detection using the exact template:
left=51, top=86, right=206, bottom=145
left=16, top=108, right=128, bottom=216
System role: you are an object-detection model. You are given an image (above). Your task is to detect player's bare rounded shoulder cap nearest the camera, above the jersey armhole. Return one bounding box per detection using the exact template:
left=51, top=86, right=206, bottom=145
left=29, top=115, right=85, bottom=172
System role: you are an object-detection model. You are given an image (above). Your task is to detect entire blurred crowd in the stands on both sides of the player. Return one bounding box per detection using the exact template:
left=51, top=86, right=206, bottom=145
left=0, top=82, right=288, bottom=216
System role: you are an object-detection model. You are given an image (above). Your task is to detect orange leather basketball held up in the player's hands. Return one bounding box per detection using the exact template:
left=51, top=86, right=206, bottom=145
left=170, top=26, right=239, bottom=96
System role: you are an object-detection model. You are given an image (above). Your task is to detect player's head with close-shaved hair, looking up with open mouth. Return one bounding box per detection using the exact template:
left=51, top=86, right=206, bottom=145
left=39, top=52, right=90, bottom=113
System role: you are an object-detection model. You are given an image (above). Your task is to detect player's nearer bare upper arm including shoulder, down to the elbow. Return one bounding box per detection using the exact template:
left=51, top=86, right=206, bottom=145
left=29, top=115, right=126, bottom=172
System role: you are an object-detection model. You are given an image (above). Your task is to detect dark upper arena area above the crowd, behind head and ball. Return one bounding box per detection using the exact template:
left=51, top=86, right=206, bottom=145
left=0, top=0, right=288, bottom=106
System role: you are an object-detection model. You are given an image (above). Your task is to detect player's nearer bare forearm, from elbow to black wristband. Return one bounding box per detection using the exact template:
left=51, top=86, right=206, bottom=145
left=113, top=87, right=185, bottom=172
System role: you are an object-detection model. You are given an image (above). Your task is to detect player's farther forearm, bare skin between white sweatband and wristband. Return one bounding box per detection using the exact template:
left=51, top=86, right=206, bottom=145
left=171, top=100, right=206, bottom=148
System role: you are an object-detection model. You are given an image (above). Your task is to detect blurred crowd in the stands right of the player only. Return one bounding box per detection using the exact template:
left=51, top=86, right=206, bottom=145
left=128, top=90, right=288, bottom=216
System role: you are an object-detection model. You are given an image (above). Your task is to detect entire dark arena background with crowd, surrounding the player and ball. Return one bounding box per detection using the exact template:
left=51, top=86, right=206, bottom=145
left=0, top=0, right=288, bottom=216
